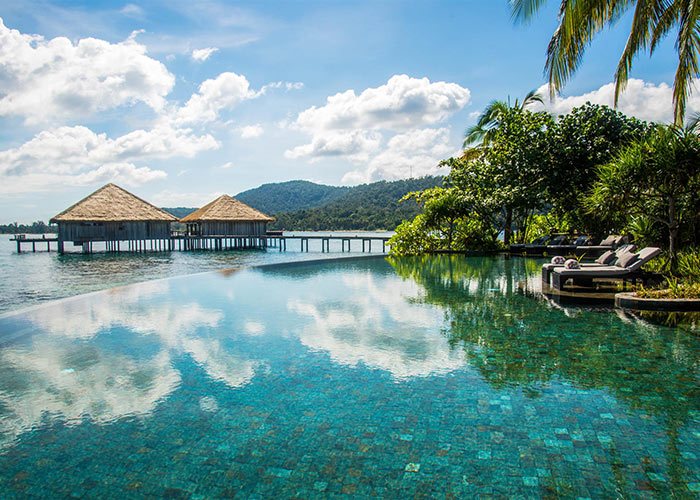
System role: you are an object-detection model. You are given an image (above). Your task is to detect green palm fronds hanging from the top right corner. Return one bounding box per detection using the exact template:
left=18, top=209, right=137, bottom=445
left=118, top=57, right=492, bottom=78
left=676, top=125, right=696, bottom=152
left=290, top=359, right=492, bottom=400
left=509, top=0, right=700, bottom=126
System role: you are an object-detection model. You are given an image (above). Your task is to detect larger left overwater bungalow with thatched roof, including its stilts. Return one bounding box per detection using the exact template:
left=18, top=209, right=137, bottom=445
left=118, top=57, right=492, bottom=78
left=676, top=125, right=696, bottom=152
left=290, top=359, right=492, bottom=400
left=51, top=183, right=177, bottom=253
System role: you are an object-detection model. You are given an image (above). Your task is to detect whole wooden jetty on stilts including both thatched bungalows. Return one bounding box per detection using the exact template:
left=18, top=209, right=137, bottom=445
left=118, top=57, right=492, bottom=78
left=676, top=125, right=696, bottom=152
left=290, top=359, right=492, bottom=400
left=11, top=184, right=389, bottom=254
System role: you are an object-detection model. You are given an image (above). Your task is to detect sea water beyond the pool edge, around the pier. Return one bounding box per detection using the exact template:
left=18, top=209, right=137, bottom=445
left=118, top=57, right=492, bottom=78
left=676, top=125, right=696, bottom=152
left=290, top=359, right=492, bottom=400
left=0, top=231, right=393, bottom=314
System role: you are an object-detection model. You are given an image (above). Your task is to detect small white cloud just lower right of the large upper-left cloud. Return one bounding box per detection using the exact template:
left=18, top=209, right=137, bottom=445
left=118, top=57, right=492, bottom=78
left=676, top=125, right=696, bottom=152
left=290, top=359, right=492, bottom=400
left=175, top=72, right=257, bottom=123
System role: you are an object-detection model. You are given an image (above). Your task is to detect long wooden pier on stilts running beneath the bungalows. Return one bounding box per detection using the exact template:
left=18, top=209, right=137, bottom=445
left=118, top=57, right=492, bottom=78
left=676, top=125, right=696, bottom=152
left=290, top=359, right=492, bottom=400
left=10, top=233, right=389, bottom=254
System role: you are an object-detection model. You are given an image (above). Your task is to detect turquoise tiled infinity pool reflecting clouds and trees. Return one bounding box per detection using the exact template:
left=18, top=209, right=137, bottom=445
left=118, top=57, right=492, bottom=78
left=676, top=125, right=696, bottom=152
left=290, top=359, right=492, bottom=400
left=0, top=257, right=700, bottom=498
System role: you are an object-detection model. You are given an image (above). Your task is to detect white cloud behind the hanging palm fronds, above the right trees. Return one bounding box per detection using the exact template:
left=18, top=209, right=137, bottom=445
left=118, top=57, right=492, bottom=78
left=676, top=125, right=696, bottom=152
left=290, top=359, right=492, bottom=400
left=538, top=78, right=700, bottom=123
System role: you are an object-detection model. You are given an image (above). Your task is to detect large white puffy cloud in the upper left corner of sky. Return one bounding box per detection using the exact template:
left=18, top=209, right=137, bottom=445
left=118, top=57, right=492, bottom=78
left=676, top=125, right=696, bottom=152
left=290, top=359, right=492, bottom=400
left=0, top=19, right=175, bottom=124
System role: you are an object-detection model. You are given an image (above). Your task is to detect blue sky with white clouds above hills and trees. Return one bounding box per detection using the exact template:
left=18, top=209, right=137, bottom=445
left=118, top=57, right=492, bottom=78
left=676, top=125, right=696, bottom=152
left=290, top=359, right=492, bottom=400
left=0, top=0, right=700, bottom=223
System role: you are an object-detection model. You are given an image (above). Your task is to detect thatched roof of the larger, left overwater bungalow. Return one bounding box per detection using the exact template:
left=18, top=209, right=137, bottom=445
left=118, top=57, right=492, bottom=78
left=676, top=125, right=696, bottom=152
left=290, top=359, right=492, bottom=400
left=51, top=183, right=177, bottom=223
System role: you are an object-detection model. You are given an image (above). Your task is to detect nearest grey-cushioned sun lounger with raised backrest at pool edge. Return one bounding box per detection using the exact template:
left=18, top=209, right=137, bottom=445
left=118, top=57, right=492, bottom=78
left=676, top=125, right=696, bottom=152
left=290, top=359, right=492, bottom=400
left=552, top=247, right=661, bottom=290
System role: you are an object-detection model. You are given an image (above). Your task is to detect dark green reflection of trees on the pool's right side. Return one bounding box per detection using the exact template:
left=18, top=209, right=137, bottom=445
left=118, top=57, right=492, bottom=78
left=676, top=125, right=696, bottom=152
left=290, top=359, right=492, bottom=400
left=391, top=255, right=700, bottom=490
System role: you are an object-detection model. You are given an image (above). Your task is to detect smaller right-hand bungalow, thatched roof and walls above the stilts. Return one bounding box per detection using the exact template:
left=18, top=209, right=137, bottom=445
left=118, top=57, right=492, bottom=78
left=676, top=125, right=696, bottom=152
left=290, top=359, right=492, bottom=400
left=180, top=194, right=275, bottom=236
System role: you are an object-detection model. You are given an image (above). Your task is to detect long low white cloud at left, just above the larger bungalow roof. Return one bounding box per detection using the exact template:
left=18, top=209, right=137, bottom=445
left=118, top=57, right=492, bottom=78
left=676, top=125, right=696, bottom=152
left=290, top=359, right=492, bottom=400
left=0, top=126, right=219, bottom=193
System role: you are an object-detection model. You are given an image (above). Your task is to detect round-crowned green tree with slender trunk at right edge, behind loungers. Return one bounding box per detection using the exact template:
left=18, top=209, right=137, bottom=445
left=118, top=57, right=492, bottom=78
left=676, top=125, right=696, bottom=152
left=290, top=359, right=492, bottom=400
left=588, top=125, right=700, bottom=270
